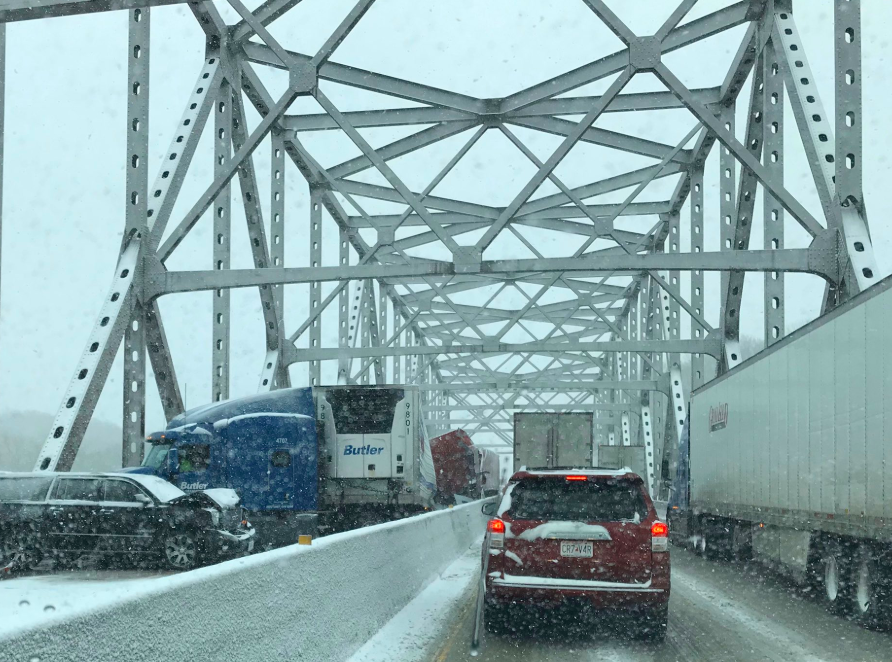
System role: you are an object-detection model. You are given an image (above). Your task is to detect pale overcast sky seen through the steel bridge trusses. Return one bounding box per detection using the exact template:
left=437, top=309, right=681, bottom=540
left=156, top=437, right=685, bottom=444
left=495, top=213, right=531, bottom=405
left=0, top=0, right=892, bottom=436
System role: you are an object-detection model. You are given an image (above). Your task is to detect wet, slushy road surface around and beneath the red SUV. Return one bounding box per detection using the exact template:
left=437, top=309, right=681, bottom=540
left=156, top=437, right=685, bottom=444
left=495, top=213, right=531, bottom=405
left=360, top=547, right=892, bottom=662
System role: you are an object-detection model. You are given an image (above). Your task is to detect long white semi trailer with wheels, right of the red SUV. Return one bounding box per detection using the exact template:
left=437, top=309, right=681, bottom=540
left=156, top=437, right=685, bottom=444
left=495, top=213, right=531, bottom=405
left=670, top=278, right=892, bottom=623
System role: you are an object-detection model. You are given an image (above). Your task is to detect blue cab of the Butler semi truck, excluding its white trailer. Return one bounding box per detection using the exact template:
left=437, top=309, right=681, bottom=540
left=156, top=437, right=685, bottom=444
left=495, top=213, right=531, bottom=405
left=127, top=388, right=320, bottom=546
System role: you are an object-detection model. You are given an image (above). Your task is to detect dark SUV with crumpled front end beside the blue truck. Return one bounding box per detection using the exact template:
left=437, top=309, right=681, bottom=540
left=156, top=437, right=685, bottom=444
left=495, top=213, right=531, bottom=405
left=0, top=473, right=254, bottom=571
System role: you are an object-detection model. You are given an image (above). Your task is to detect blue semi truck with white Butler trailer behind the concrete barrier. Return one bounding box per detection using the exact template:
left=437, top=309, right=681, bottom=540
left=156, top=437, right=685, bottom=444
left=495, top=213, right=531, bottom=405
left=125, top=385, right=435, bottom=548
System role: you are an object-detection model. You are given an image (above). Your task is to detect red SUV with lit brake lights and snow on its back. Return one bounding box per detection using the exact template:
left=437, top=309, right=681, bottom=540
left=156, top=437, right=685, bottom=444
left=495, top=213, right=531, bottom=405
left=483, top=469, right=669, bottom=639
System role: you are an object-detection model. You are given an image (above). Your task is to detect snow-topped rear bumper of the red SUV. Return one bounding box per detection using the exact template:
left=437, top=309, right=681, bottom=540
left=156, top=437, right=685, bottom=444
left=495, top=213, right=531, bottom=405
left=486, top=573, right=669, bottom=608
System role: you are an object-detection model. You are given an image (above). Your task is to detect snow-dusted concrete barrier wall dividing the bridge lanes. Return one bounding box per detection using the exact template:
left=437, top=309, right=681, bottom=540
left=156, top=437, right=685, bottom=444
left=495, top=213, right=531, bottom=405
left=0, top=502, right=485, bottom=662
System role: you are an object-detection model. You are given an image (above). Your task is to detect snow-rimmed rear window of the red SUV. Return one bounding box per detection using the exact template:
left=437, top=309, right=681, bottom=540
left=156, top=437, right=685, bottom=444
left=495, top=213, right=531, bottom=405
left=507, top=478, right=647, bottom=522
